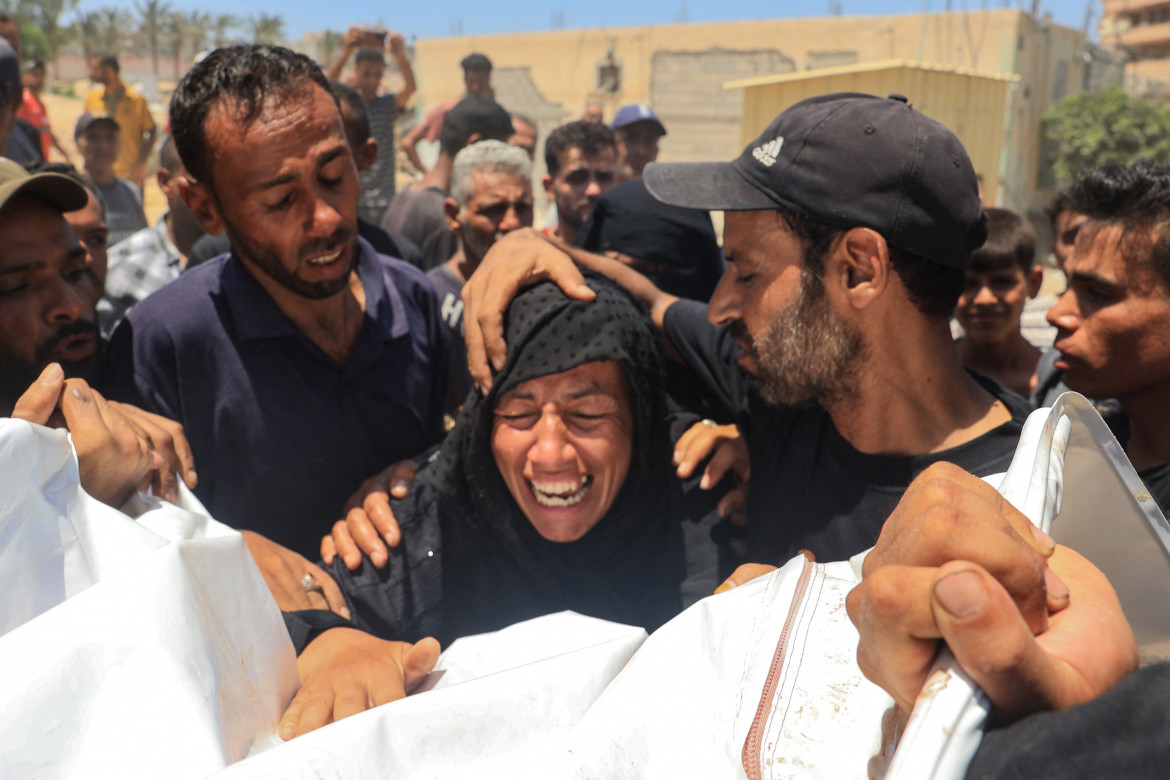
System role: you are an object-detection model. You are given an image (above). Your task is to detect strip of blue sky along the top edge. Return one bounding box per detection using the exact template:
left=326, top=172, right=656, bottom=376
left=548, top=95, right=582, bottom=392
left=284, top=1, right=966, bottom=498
left=81, top=0, right=1101, bottom=39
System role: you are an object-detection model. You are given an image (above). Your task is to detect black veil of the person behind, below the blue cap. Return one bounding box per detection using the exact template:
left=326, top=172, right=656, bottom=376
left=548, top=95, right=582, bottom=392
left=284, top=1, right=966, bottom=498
left=574, top=179, right=723, bottom=302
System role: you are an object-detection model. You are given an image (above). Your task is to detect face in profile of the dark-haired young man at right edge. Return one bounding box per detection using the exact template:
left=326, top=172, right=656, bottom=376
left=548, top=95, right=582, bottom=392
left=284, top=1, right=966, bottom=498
left=1048, top=222, right=1170, bottom=405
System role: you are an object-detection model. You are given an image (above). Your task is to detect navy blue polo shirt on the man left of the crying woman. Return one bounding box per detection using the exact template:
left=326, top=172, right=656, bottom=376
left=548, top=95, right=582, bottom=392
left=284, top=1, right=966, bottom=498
left=105, top=240, right=448, bottom=560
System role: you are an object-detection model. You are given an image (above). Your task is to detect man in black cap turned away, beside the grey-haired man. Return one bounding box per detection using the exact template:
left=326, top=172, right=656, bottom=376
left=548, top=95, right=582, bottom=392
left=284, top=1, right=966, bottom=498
left=381, top=95, right=514, bottom=270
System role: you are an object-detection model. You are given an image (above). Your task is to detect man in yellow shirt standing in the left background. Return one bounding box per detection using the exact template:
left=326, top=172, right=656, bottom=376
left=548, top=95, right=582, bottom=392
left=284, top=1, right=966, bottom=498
left=85, top=54, right=156, bottom=188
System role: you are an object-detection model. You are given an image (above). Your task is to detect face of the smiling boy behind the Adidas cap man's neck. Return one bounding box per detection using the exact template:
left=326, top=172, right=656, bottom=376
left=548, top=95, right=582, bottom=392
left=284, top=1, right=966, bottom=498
left=955, top=263, right=1044, bottom=344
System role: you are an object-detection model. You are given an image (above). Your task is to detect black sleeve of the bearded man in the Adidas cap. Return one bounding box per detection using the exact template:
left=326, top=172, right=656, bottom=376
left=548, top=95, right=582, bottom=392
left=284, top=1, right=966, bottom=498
left=662, top=301, right=749, bottom=417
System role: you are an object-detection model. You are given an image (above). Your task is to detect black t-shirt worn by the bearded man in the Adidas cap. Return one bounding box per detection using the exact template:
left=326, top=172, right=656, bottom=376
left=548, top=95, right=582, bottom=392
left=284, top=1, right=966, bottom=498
left=663, top=301, right=1032, bottom=564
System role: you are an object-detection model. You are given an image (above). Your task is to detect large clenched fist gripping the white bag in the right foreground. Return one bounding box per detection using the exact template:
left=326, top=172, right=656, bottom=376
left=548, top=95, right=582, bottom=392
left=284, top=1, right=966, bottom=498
left=847, top=463, right=1137, bottom=717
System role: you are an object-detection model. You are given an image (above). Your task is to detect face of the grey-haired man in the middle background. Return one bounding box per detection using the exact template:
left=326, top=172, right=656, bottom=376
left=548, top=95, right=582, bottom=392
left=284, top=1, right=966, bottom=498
left=452, top=171, right=532, bottom=262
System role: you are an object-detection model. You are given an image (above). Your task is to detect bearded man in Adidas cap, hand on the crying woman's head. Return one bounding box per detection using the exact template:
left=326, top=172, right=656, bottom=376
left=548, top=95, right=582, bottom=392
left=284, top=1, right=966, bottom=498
left=463, top=94, right=1030, bottom=564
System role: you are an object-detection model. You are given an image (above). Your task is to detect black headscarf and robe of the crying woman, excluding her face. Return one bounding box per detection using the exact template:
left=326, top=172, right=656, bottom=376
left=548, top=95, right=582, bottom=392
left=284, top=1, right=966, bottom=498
left=332, top=272, right=686, bottom=641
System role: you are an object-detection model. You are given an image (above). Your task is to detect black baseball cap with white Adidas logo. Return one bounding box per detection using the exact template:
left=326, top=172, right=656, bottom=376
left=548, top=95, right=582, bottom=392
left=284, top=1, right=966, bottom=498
left=642, top=92, right=987, bottom=268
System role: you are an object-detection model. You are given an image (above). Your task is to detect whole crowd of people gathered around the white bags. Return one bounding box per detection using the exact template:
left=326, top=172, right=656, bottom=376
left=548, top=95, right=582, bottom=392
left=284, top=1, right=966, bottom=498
left=0, top=22, right=1170, bottom=776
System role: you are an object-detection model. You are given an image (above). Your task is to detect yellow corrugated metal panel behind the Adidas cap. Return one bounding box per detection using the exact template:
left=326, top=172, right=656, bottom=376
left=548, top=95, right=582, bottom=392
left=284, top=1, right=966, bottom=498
left=732, top=61, right=1018, bottom=199
